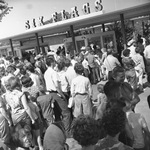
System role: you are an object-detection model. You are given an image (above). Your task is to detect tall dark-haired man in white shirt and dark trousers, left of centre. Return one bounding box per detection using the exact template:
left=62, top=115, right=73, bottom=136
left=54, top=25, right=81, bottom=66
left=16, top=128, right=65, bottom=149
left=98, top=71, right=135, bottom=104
left=44, top=57, right=71, bottom=134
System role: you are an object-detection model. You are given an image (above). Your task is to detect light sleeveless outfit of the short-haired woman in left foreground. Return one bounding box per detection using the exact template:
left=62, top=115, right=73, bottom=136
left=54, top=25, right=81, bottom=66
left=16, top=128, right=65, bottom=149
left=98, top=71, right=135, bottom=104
left=5, top=90, right=27, bottom=125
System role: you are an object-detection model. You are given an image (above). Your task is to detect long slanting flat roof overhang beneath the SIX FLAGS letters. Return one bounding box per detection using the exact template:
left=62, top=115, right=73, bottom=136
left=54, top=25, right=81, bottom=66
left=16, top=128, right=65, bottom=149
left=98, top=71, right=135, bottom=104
left=0, top=3, right=150, bottom=41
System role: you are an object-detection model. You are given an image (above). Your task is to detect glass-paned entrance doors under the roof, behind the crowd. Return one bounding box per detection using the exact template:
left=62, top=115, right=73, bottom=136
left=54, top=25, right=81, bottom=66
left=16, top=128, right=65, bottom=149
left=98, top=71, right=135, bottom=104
left=64, top=31, right=117, bottom=55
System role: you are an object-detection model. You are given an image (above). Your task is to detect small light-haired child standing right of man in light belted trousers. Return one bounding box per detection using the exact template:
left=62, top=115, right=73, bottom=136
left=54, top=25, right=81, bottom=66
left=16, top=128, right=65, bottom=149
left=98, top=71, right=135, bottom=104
left=93, top=82, right=107, bottom=119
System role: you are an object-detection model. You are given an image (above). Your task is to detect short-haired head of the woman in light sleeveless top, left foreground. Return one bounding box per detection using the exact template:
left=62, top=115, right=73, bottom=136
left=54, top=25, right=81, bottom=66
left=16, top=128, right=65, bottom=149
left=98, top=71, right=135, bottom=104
left=7, top=77, right=21, bottom=91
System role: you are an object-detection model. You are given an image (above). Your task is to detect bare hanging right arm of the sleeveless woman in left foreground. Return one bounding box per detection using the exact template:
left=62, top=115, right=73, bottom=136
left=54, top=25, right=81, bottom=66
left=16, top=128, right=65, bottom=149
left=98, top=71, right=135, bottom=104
left=21, top=94, right=35, bottom=124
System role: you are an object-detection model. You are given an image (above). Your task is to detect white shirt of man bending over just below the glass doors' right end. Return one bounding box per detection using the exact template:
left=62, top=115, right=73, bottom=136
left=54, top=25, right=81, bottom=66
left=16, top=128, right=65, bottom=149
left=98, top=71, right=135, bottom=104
left=104, top=55, right=120, bottom=71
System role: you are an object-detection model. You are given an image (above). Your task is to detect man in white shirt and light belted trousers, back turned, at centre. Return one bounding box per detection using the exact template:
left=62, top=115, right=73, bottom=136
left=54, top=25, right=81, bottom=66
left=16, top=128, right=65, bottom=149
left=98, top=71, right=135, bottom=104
left=71, top=63, right=92, bottom=118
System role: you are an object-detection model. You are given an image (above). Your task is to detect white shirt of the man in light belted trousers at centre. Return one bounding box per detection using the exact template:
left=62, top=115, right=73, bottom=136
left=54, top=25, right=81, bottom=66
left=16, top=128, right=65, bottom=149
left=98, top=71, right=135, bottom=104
left=71, top=75, right=92, bottom=96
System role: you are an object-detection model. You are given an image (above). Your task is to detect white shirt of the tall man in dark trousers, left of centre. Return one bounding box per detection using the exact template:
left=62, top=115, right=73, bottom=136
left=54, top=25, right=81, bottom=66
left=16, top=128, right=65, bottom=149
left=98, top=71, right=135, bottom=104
left=44, top=67, right=60, bottom=91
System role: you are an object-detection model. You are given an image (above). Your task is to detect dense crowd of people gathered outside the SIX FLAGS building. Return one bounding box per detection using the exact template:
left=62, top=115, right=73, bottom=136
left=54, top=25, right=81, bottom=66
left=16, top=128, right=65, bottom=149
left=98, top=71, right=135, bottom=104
left=0, top=34, right=150, bottom=150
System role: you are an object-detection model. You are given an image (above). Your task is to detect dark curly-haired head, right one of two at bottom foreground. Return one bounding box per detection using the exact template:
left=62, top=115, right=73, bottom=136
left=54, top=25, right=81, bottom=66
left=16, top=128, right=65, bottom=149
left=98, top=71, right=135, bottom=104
left=102, top=108, right=126, bottom=137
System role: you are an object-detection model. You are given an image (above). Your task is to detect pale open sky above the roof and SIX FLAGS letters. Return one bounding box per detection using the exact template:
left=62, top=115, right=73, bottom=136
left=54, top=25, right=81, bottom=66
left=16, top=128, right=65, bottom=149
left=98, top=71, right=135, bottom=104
left=0, top=0, right=150, bottom=38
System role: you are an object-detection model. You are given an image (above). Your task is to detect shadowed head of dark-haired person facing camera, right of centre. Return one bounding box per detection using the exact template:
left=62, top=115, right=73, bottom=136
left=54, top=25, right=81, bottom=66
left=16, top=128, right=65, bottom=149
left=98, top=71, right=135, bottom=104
left=112, top=66, right=125, bottom=82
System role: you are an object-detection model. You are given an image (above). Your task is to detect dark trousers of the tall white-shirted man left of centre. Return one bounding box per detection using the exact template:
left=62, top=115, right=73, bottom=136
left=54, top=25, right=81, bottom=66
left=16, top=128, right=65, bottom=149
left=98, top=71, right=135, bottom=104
left=50, top=92, right=72, bottom=134
